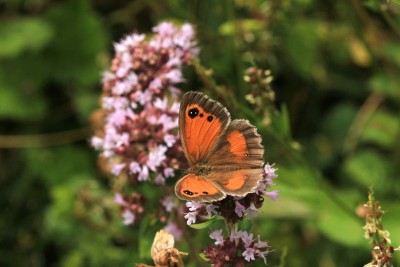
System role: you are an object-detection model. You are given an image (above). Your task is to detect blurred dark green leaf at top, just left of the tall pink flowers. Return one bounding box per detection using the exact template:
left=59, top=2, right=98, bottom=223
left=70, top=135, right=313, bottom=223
left=48, top=0, right=105, bottom=86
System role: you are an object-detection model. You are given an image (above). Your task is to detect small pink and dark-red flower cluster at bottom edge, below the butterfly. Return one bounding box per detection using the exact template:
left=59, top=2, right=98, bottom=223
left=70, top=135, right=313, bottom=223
left=204, top=230, right=269, bottom=267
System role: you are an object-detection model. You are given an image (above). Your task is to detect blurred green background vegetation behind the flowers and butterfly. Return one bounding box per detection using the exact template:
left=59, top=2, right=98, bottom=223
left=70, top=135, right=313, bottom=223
left=0, top=0, right=400, bottom=267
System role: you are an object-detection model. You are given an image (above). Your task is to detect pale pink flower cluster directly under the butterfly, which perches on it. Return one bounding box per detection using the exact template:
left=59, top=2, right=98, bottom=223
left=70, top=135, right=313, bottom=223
left=185, top=164, right=279, bottom=225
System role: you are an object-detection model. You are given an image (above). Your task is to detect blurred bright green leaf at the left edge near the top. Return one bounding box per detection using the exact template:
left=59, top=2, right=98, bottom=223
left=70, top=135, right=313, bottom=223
left=0, top=17, right=53, bottom=58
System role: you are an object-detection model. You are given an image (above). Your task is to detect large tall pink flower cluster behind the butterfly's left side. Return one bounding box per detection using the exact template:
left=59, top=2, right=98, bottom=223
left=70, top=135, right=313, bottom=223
left=91, top=22, right=198, bottom=184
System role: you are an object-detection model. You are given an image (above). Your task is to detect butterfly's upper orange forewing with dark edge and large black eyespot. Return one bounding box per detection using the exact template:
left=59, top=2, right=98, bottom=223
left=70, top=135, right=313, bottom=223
left=179, top=92, right=230, bottom=165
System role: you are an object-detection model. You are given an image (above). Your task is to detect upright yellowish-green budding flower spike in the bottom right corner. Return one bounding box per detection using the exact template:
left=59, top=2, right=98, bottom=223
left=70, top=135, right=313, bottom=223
left=361, top=190, right=398, bottom=267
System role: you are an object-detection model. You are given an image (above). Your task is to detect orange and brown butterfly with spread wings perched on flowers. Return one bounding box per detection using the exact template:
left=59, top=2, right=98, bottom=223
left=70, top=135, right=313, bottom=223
left=175, top=91, right=264, bottom=202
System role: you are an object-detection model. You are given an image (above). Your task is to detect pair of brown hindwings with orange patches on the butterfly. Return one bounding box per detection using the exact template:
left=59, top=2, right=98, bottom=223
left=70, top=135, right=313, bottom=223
left=207, top=120, right=264, bottom=196
